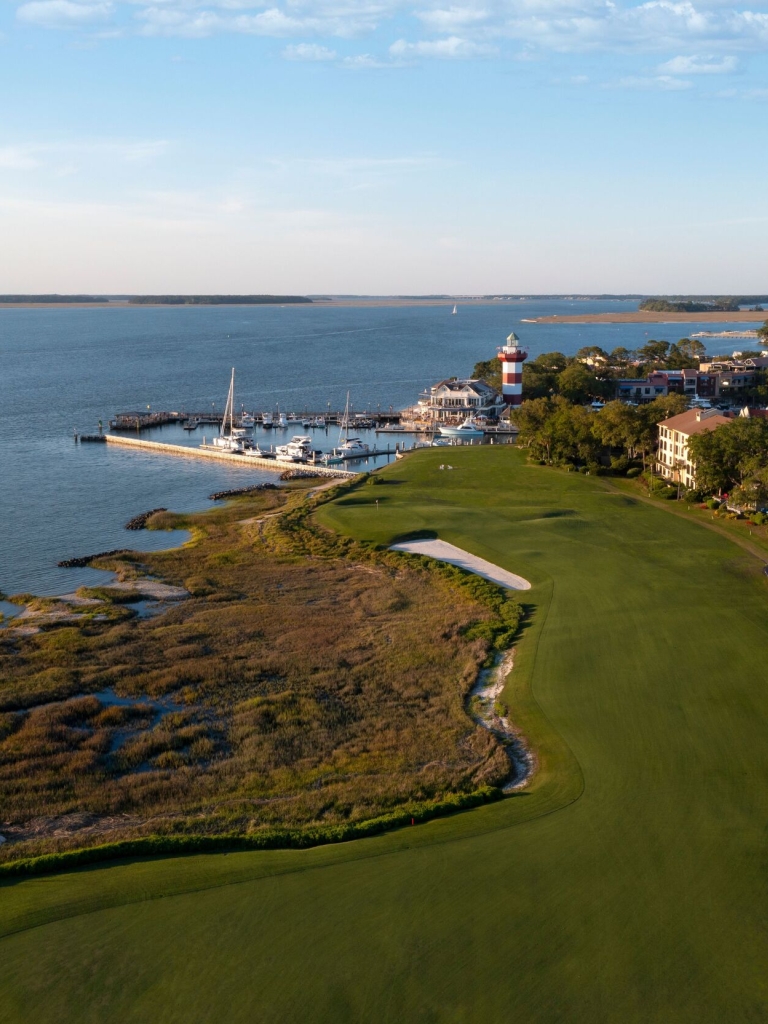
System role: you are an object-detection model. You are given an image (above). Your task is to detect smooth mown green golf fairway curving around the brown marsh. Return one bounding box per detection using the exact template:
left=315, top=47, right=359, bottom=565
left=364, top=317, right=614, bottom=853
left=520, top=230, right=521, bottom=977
left=0, top=447, right=768, bottom=1024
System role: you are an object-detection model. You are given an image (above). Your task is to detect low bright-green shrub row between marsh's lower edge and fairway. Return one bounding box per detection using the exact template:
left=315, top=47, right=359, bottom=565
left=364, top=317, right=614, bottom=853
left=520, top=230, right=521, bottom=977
left=0, top=785, right=504, bottom=880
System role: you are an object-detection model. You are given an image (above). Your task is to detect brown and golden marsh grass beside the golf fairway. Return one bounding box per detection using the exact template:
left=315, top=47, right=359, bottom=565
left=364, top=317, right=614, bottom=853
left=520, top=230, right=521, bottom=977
left=0, top=483, right=521, bottom=859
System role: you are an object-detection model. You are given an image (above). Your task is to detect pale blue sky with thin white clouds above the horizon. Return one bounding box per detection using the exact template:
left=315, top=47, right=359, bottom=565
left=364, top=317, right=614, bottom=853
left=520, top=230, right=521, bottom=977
left=0, top=0, right=768, bottom=294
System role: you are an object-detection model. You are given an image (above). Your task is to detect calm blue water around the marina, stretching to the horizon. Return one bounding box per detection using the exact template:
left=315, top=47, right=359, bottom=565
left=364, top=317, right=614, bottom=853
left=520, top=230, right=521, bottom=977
left=0, top=301, right=748, bottom=594
